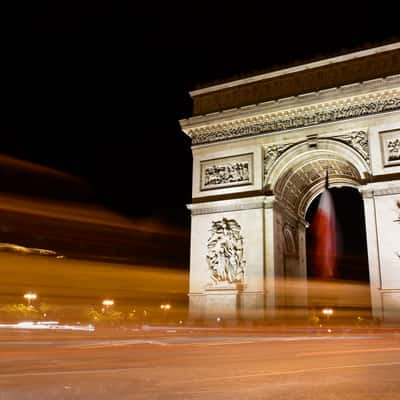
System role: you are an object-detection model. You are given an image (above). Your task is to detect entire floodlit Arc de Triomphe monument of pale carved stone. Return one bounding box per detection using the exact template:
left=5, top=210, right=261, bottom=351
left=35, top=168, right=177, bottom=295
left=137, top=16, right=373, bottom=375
left=180, top=43, right=400, bottom=319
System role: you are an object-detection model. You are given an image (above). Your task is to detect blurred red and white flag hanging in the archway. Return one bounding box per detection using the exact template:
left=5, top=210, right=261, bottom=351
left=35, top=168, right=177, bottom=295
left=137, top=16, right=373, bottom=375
left=311, top=189, right=336, bottom=278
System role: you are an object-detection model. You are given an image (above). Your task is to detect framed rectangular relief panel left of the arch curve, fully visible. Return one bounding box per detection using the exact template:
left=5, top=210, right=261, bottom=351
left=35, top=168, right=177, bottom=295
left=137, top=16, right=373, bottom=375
left=200, top=153, right=253, bottom=191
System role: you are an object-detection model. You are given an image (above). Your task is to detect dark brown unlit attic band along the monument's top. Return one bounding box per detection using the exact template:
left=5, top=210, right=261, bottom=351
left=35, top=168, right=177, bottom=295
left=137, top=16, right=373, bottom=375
left=193, top=46, right=400, bottom=115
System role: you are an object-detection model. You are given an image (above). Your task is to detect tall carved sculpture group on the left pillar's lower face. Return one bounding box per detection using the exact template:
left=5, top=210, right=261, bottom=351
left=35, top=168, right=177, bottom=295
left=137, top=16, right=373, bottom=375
left=207, top=218, right=246, bottom=285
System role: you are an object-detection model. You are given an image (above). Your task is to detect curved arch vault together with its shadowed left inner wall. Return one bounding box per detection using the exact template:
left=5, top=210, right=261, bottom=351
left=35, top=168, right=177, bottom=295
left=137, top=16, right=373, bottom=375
left=258, top=139, right=371, bottom=318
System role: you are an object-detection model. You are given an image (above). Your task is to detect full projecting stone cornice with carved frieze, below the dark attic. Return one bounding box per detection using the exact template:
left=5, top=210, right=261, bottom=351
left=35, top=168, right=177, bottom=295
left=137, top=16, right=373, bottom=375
left=180, top=75, right=400, bottom=145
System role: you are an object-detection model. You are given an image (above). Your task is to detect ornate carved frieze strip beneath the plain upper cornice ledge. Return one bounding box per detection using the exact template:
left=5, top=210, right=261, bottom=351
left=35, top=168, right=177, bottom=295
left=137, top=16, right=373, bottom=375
left=182, top=89, right=400, bottom=144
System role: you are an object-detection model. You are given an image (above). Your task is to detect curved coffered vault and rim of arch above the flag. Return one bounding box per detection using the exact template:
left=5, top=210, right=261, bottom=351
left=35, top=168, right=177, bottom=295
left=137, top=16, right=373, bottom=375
left=265, top=139, right=370, bottom=219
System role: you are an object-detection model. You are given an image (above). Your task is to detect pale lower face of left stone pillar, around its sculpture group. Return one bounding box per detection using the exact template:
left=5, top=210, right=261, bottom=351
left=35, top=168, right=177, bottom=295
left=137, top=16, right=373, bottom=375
left=189, top=196, right=265, bottom=321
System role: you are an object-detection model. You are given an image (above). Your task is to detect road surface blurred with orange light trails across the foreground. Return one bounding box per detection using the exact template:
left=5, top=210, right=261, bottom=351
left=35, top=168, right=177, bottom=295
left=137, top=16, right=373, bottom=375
left=0, top=329, right=400, bottom=400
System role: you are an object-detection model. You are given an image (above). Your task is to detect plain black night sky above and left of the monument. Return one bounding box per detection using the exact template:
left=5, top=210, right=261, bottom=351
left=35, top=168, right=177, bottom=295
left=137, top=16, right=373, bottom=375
left=0, top=1, right=399, bottom=228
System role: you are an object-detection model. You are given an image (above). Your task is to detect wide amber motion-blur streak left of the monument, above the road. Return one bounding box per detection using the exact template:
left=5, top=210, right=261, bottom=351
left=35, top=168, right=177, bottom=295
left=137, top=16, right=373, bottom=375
left=0, top=253, right=187, bottom=325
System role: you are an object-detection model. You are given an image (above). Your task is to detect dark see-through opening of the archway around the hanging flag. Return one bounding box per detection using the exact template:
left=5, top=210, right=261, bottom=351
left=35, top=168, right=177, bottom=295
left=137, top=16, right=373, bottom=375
left=305, top=186, right=371, bottom=323
